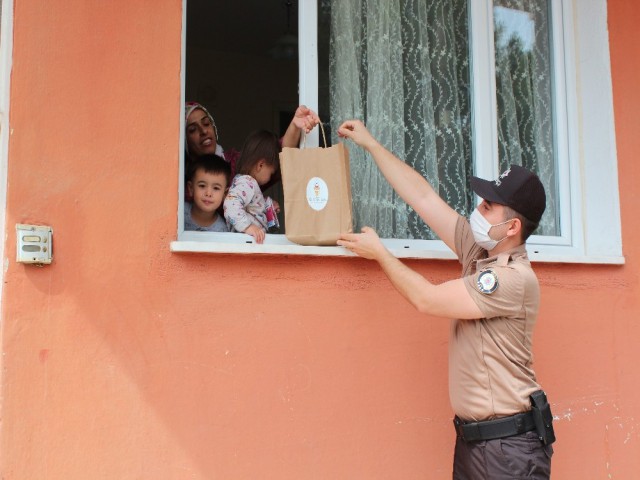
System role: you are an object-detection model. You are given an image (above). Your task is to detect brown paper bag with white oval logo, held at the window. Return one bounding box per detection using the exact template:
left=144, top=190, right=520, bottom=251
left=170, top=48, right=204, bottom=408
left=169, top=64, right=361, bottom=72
left=280, top=127, right=353, bottom=245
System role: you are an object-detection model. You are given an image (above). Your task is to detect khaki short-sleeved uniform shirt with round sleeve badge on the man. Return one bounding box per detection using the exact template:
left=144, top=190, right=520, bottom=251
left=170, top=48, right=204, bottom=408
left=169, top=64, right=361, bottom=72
left=449, top=217, right=540, bottom=421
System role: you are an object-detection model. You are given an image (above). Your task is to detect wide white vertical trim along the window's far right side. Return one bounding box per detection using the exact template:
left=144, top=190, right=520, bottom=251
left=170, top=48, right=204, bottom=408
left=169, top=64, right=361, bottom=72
left=565, top=0, right=622, bottom=256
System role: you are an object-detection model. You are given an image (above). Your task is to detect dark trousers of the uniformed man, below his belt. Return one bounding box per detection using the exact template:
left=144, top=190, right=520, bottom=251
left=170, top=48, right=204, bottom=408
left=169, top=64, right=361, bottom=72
left=453, top=432, right=553, bottom=480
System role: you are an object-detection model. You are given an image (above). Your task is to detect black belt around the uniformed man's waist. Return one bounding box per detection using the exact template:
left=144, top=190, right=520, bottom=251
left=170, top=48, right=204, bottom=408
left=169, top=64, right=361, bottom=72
left=453, top=411, right=536, bottom=442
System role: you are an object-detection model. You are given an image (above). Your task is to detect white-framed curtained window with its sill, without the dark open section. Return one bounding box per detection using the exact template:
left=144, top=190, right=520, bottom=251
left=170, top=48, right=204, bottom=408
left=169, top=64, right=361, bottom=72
left=174, top=0, right=623, bottom=263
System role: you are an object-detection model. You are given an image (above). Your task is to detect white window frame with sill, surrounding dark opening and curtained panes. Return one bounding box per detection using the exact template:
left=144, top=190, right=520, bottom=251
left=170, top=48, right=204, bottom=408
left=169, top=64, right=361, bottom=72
left=171, top=0, right=624, bottom=264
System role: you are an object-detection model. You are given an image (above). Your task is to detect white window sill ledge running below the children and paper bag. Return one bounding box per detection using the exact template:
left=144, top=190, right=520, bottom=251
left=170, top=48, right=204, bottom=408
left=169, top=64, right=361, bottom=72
left=170, top=232, right=625, bottom=265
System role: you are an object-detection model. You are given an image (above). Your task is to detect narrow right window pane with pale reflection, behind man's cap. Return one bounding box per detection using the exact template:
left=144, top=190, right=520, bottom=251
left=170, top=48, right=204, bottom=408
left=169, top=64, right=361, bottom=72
left=493, top=0, right=561, bottom=235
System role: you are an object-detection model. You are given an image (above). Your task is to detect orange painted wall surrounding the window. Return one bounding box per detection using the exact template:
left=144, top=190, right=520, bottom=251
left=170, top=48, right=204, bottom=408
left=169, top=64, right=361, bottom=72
left=0, top=0, right=640, bottom=480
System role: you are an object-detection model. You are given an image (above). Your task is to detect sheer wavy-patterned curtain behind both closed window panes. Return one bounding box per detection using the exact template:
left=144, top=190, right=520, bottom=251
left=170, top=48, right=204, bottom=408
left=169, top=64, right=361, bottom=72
left=328, top=0, right=560, bottom=239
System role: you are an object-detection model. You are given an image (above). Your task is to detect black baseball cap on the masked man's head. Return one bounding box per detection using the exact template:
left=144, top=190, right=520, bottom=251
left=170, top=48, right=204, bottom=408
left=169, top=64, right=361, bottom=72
left=471, top=165, right=547, bottom=223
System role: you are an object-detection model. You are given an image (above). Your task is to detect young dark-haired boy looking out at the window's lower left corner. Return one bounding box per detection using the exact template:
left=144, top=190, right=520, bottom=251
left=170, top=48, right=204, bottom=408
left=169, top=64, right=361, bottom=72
left=184, top=155, right=231, bottom=232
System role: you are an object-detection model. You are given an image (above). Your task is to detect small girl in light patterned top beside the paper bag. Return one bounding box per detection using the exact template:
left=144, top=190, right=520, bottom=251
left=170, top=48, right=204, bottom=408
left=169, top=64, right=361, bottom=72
left=224, top=130, right=280, bottom=243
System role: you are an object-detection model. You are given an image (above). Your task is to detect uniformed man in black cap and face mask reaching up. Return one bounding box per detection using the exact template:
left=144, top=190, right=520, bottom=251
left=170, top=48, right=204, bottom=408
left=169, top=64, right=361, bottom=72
left=338, top=120, right=555, bottom=480
